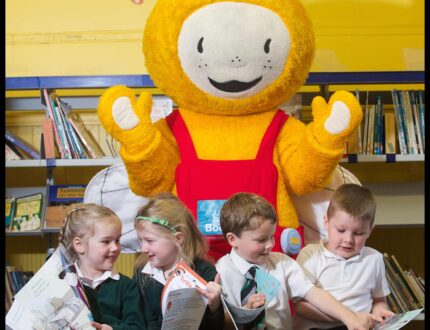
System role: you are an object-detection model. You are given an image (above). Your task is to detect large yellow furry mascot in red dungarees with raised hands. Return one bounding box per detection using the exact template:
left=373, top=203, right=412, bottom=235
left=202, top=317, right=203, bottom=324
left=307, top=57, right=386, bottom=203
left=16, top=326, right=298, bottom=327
left=98, top=0, right=362, bottom=259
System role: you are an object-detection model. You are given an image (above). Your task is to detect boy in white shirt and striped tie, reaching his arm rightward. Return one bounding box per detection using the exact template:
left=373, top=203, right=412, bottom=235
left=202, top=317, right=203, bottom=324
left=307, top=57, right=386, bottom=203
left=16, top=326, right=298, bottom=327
left=216, top=193, right=373, bottom=330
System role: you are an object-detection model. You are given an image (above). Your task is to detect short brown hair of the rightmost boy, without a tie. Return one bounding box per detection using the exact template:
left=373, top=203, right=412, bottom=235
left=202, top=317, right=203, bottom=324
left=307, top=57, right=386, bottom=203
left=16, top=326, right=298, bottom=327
left=327, top=183, right=376, bottom=226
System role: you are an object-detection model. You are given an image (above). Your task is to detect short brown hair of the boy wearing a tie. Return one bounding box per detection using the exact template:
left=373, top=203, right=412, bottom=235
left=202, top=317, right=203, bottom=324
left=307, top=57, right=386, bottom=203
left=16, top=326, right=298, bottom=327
left=220, top=192, right=277, bottom=237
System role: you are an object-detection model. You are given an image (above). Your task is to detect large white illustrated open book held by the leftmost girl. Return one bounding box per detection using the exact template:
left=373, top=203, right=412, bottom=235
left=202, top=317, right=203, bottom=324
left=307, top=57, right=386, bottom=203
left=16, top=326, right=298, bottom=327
left=6, top=246, right=95, bottom=330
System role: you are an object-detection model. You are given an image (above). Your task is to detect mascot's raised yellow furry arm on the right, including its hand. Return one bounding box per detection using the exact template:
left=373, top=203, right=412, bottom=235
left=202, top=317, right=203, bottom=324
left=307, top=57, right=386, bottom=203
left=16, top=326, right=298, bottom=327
left=277, top=91, right=362, bottom=195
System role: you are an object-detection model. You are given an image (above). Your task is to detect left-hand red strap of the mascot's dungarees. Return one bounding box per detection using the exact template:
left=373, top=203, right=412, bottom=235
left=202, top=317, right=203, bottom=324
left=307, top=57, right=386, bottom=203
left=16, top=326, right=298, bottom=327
left=166, top=110, right=198, bottom=160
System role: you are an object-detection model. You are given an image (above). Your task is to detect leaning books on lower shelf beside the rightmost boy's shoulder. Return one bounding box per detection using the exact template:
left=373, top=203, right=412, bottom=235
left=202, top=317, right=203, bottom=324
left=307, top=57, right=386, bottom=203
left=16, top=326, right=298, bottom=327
left=383, top=253, right=425, bottom=314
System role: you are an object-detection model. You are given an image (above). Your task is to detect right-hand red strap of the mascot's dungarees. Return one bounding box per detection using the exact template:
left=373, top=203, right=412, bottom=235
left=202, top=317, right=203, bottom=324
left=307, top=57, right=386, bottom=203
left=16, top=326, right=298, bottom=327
left=255, top=110, right=288, bottom=160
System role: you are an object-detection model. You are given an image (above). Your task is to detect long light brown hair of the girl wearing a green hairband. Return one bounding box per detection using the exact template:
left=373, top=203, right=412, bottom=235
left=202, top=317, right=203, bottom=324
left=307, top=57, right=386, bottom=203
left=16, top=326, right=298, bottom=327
left=134, top=193, right=209, bottom=268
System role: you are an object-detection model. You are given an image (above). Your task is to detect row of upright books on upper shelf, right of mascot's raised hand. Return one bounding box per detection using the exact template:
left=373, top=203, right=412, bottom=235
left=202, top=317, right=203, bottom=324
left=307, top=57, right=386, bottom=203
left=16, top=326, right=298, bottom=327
left=345, top=89, right=425, bottom=155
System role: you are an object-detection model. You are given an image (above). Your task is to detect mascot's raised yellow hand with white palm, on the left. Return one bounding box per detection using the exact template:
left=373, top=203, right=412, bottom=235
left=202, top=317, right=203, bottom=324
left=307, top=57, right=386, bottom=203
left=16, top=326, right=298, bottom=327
left=97, top=86, right=155, bottom=144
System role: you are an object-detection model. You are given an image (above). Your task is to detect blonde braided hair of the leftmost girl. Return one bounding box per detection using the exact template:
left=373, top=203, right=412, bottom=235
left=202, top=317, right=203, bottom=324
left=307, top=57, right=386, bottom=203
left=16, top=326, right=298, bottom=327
left=59, top=203, right=121, bottom=261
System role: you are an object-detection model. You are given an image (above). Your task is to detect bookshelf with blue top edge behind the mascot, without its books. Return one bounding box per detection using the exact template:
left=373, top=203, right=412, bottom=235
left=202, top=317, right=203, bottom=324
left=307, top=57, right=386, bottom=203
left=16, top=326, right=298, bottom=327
left=5, top=71, right=425, bottom=302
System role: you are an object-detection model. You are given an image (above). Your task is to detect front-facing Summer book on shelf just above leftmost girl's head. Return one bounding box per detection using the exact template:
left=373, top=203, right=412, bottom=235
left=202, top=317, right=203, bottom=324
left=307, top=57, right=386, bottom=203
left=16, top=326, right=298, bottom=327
left=45, top=185, right=86, bottom=228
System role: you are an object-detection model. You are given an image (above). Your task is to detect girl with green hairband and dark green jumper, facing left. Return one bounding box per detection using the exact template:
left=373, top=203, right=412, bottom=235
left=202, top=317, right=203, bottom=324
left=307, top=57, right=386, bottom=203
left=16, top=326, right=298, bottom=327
left=133, top=193, right=224, bottom=330
